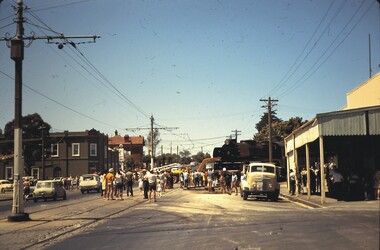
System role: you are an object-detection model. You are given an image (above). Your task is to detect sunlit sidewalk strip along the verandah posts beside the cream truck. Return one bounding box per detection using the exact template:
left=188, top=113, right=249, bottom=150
left=280, top=182, right=338, bottom=208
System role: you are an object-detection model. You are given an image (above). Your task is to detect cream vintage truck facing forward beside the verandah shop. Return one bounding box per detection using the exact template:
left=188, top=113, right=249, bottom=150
left=240, top=162, right=280, bottom=201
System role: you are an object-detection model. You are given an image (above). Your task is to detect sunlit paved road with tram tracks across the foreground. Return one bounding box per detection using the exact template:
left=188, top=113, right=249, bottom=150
left=0, top=188, right=379, bottom=249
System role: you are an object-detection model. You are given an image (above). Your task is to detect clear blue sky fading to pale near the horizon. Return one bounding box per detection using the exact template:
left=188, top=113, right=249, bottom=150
left=0, top=0, right=380, bottom=155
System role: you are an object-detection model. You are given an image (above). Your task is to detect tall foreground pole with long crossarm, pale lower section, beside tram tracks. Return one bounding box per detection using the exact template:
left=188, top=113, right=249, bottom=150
left=0, top=0, right=99, bottom=222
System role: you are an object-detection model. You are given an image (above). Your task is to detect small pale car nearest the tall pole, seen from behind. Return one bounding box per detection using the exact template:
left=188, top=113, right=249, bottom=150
left=33, top=180, right=66, bottom=202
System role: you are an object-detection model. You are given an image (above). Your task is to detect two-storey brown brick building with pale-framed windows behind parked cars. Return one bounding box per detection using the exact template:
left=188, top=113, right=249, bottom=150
left=0, top=129, right=119, bottom=179
